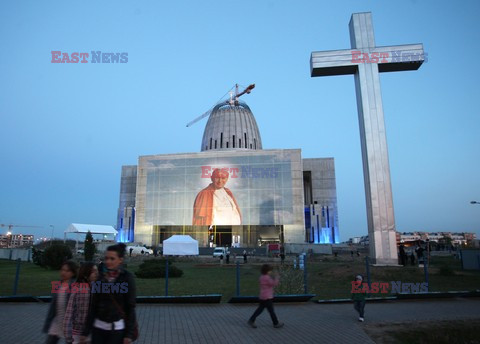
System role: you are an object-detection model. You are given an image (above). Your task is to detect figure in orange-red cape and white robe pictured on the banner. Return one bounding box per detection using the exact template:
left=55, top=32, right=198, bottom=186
left=192, top=168, right=242, bottom=226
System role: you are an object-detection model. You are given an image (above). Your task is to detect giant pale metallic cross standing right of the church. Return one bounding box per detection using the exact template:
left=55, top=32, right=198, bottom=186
left=310, top=12, right=425, bottom=265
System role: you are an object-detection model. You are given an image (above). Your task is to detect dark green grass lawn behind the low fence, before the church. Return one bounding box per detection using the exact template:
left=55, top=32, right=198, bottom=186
left=0, top=255, right=480, bottom=301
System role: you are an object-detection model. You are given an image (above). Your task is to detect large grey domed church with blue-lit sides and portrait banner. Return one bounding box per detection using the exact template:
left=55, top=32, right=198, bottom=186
left=117, top=98, right=339, bottom=248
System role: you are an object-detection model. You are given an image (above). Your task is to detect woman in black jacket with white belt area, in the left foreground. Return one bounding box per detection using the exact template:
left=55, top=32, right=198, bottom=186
left=82, top=243, right=136, bottom=344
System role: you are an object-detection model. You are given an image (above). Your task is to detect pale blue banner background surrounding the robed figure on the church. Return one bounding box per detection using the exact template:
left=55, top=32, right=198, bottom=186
left=143, top=152, right=294, bottom=226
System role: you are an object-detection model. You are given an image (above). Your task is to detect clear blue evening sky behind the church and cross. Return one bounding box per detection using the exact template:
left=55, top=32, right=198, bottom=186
left=0, top=0, right=480, bottom=240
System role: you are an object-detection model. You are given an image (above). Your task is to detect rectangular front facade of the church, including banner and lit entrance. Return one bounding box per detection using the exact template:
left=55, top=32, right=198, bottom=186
left=131, top=149, right=305, bottom=247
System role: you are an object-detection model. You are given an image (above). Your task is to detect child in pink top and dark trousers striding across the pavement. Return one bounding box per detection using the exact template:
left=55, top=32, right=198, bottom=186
left=248, top=264, right=284, bottom=328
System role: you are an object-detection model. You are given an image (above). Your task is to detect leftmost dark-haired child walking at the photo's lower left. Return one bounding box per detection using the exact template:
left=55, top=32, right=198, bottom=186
left=43, top=260, right=78, bottom=344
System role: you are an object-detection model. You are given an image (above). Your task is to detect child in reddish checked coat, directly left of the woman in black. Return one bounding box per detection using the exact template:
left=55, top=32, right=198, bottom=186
left=63, top=262, right=98, bottom=344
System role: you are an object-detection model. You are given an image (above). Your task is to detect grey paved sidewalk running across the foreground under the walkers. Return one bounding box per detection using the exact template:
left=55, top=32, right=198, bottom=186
left=0, top=298, right=480, bottom=344
